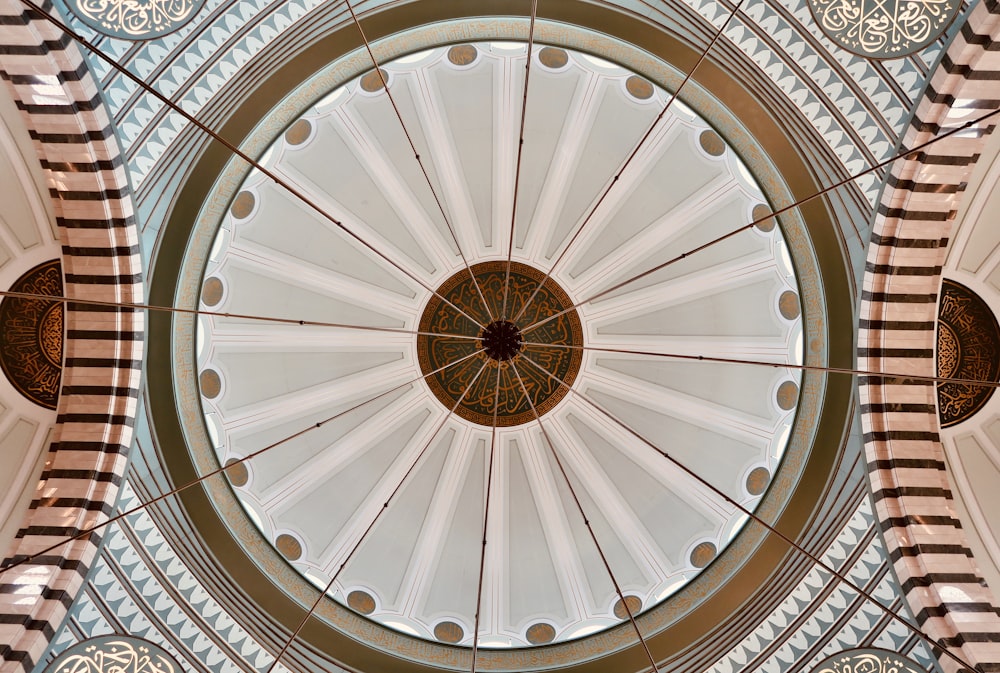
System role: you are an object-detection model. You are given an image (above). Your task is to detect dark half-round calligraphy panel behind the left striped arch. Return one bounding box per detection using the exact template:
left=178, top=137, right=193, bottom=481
left=0, top=259, right=63, bottom=409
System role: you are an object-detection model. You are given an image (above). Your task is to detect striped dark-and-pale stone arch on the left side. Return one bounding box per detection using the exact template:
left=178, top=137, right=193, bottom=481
left=0, top=0, right=144, bottom=673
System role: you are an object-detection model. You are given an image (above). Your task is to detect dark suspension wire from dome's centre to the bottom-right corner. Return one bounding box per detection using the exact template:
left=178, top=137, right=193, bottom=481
left=521, top=353, right=974, bottom=671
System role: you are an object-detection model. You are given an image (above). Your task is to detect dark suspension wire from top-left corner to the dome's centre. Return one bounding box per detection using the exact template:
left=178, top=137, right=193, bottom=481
left=12, top=0, right=485, bottom=328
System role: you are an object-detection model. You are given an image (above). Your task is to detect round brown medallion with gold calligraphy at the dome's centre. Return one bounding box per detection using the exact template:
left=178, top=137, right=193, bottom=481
left=417, top=261, right=583, bottom=427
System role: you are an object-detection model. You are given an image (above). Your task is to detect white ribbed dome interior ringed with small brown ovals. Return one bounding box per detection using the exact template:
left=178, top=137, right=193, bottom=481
left=197, top=42, right=803, bottom=647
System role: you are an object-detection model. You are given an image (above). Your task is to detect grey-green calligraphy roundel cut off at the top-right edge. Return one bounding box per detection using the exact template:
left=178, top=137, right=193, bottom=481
left=809, top=0, right=960, bottom=58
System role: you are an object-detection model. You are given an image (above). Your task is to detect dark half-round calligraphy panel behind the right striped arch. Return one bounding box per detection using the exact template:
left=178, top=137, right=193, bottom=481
left=937, top=279, right=1000, bottom=428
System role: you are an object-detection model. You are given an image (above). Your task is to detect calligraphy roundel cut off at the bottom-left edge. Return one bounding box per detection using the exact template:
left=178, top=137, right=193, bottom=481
left=46, top=635, right=181, bottom=673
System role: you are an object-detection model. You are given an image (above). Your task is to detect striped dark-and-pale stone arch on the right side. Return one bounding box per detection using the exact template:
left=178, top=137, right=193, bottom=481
left=858, top=0, right=1000, bottom=671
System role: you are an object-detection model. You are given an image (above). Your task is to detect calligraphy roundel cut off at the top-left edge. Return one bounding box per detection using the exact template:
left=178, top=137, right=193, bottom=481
left=70, top=0, right=203, bottom=39
